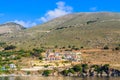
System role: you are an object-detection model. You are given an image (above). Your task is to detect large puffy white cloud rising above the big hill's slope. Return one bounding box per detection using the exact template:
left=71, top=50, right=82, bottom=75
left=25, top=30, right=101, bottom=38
left=39, top=1, right=73, bottom=22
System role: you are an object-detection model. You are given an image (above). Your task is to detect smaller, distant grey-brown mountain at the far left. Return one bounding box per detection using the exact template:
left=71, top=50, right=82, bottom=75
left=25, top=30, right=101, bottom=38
left=0, top=22, right=24, bottom=34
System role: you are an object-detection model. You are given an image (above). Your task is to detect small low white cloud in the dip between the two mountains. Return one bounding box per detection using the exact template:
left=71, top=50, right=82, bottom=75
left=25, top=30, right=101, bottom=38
left=13, top=20, right=37, bottom=28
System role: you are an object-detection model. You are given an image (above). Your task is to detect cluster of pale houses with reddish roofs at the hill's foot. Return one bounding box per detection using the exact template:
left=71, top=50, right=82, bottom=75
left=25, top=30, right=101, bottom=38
left=45, top=51, right=82, bottom=61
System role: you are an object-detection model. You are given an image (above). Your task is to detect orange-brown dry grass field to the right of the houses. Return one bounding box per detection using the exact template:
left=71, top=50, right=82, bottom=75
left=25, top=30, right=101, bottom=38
left=82, top=50, right=120, bottom=68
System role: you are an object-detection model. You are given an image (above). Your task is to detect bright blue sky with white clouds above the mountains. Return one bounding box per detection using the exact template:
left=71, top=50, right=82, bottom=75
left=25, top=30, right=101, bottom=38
left=0, top=0, right=120, bottom=28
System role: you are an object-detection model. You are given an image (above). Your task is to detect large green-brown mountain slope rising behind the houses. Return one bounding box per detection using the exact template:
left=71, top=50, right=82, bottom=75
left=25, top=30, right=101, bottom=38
left=0, top=12, right=120, bottom=49
